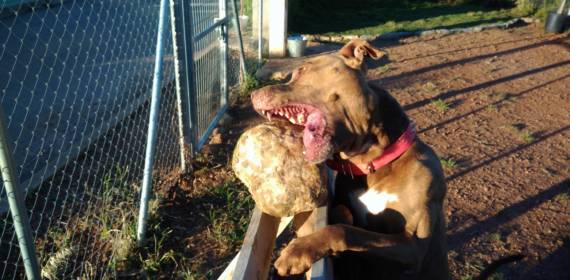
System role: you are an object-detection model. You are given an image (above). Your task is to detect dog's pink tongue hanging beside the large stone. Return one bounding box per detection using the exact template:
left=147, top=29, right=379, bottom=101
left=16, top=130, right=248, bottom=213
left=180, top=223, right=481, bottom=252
left=303, top=110, right=328, bottom=163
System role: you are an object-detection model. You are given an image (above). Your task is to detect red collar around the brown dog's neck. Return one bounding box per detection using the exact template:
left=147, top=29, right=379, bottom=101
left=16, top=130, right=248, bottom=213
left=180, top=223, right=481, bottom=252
left=327, top=123, right=416, bottom=176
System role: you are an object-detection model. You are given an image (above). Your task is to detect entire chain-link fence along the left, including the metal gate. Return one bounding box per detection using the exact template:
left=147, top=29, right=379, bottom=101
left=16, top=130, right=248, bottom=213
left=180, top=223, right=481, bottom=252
left=0, top=0, right=256, bottom=279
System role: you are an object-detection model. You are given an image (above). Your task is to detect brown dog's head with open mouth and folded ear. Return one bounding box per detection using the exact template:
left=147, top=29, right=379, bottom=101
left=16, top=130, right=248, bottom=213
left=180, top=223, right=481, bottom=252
left=251, top=39, right=385, bottom=163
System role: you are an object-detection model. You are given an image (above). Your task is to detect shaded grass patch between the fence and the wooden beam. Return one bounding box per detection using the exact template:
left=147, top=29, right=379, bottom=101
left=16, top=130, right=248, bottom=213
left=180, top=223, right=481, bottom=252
left=126, top=174, right=254, bottom=280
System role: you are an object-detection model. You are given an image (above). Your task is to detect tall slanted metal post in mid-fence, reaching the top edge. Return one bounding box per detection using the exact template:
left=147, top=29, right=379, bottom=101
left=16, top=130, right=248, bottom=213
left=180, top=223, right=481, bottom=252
left=137, top=0, right=168, bottom=244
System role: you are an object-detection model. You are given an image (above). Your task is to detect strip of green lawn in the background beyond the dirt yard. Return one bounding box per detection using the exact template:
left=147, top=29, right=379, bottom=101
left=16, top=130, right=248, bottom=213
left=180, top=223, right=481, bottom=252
left=289, top=1, right=529, bottom=35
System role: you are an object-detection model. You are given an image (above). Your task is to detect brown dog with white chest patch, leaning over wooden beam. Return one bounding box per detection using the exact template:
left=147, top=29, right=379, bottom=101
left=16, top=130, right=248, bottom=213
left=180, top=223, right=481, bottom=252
left=252, top=40, right=449, bottom=279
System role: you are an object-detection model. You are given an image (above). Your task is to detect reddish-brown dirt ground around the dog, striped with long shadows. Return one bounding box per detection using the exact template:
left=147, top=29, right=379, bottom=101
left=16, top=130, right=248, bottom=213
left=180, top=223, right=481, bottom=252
left=154, top=23, right=570, bottom=279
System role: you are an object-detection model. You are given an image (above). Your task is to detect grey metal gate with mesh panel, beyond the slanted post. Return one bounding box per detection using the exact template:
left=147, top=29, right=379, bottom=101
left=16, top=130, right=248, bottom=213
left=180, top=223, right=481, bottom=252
left=172, top=0, right=235, bottom=169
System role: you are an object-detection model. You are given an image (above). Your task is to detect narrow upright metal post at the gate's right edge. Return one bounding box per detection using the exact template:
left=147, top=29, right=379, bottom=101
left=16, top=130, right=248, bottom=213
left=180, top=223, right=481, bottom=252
left=218, top=0, right=229, bottom=108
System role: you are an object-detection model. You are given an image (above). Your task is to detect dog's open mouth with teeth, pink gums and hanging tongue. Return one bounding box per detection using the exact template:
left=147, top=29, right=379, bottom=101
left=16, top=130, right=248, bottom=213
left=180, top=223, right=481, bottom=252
left=258, top=104, right=333, bottom=163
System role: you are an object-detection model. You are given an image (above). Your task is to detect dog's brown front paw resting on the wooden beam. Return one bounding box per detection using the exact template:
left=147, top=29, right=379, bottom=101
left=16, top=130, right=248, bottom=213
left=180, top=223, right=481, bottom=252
left=275, top=236, right=329, bottom=276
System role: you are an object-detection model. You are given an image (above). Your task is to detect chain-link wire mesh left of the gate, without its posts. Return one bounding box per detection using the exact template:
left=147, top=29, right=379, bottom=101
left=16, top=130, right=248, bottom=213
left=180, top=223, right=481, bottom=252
left=0, top=0, right=179, bottom=279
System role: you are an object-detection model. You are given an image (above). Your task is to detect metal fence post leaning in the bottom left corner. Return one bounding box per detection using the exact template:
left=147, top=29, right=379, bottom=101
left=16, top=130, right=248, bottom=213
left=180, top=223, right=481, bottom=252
left=0, top=107, right=40, bottom=279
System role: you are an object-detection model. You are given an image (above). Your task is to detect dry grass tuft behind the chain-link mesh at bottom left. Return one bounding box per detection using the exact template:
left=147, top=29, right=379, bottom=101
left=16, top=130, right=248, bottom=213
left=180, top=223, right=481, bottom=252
left=37, top=166, right=143, bottom=279
